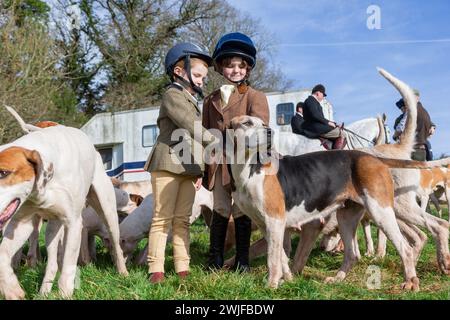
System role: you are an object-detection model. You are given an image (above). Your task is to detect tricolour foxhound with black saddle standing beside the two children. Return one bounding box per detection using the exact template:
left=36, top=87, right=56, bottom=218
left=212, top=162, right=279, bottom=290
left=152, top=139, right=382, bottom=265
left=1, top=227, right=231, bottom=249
left=231, top=116, right=448, bottom=290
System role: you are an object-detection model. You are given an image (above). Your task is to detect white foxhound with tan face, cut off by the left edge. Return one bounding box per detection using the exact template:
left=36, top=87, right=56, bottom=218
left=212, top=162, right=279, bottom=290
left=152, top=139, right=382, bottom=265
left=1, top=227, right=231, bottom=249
left=0, top=109, right=128, bottom=299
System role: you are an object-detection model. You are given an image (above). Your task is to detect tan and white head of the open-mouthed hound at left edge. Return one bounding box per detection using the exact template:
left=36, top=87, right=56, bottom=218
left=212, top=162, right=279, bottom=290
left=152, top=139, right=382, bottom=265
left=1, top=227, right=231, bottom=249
left=0, top=147, right=52, bottom=230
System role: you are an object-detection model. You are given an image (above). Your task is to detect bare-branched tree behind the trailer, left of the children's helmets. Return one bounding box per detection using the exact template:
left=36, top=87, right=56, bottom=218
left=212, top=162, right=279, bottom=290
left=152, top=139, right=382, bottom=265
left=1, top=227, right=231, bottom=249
left=80, top=0, right=223, bottom=110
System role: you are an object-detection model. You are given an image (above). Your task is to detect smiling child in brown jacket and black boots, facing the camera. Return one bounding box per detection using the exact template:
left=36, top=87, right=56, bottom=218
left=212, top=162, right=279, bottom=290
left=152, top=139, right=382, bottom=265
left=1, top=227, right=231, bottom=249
left=203, top=32, right=269, bottom=271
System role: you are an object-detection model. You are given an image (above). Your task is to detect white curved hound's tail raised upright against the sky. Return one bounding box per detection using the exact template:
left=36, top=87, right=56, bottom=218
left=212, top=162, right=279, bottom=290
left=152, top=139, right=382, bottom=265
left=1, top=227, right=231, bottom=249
left=377, top=68, right=417, bottom=155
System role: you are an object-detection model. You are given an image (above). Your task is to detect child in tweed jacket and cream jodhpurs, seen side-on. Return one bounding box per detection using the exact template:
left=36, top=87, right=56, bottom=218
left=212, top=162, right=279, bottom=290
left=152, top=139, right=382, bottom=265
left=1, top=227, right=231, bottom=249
left=145, top=43, right=214, bottom=283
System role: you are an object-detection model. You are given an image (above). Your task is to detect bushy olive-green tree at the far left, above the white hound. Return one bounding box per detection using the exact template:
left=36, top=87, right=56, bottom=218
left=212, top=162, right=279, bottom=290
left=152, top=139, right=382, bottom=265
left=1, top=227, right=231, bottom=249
left=0, top=10, right=87, bottom=143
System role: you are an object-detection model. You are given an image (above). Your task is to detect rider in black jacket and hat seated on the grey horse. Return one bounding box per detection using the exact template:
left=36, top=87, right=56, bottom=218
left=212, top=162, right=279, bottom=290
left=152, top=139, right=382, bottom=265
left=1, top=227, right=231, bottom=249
left=302, top=84, right=347, bottom=149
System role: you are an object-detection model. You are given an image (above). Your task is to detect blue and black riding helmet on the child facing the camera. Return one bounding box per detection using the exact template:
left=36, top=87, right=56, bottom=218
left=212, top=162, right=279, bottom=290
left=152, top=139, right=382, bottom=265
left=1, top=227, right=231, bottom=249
left=213, top=32, right=256, bottom=68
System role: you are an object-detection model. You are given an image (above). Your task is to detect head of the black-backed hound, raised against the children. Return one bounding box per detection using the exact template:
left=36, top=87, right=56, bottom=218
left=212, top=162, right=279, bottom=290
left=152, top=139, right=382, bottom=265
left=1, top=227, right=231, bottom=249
left=230, top=116, right=273, bottom=151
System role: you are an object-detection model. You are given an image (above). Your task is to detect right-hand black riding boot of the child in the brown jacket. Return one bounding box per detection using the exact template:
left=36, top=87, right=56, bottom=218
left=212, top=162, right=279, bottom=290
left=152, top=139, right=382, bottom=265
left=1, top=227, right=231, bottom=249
left=233, top=215, right=252, bottom=272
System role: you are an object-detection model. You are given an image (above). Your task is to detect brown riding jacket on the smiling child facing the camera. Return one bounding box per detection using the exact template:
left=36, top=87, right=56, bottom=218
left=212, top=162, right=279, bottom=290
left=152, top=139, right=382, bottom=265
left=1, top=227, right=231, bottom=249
left=202, top=85, right=270, bottom=190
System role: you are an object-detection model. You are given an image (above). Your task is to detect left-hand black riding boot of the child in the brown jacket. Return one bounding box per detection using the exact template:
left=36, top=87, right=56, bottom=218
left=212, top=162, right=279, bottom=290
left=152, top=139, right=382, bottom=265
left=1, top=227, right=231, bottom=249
left=208, top=211, right=228, bottom=269
